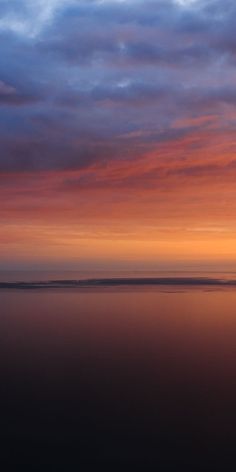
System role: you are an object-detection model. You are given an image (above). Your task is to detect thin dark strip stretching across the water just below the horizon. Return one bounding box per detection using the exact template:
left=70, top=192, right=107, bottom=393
left=0, top=277, right=236, bottom=290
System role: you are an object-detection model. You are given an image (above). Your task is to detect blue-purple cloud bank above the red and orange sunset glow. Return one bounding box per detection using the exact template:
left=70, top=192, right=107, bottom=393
left=0, top=0, right=236, bottom=172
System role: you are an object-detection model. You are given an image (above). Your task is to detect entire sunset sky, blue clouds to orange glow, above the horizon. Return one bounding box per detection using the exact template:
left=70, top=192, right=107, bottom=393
left=0, top=0, right=236, bottom=269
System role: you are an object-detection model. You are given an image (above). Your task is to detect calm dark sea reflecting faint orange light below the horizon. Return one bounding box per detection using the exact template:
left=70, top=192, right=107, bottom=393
left=0, top=273, right=236, bottom=471
